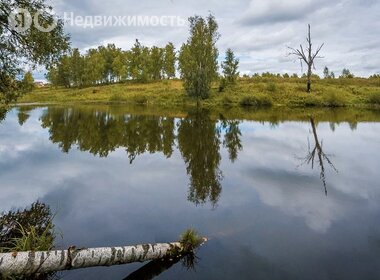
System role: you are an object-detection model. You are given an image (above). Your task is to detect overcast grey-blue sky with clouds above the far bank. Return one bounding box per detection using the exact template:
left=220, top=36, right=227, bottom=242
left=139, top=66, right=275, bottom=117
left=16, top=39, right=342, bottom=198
left=34, top=0, right=380, bottom=80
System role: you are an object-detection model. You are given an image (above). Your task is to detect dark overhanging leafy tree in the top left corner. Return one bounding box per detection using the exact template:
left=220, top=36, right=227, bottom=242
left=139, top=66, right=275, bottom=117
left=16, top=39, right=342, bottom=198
left=0, top=0, right=69, bottom=103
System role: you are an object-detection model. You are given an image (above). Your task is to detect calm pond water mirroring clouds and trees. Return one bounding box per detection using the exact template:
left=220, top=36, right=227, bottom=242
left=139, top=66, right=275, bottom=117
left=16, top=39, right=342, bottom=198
left=0, top=106, right=380, bottom=279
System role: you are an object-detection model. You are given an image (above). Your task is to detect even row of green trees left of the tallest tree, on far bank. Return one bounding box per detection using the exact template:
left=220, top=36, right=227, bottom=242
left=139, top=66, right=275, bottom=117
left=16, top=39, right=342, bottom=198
left=47, top=40, right=176, bottom=87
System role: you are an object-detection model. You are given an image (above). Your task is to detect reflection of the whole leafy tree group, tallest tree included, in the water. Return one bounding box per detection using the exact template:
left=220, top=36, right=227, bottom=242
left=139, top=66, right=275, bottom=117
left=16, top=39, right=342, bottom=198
left=41, top=107, right=242, bottom=206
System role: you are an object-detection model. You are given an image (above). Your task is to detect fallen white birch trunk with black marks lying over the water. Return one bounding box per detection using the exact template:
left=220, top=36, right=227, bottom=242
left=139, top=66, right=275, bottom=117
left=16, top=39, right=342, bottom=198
left=0, top=242, right=193, bottom=279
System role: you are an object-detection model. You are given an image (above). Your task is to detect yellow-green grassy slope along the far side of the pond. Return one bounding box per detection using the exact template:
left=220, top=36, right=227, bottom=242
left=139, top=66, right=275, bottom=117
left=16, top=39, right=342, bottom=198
left=19, top=77, right=380, bottom=108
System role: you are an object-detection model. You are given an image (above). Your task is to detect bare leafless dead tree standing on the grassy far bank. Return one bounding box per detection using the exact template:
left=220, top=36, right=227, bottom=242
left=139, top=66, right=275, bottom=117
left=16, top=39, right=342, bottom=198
left=289, top=24, right=324, bottom=93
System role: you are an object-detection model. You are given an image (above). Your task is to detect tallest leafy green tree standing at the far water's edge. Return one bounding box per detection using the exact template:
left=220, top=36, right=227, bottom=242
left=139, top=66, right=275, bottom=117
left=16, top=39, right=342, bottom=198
left=179, top=15, right=219, bottom=99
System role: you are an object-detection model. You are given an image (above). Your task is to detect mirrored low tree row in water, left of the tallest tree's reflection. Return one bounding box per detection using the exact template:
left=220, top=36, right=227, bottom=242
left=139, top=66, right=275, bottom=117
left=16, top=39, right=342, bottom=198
left=41, top=108, right=175, bottom=163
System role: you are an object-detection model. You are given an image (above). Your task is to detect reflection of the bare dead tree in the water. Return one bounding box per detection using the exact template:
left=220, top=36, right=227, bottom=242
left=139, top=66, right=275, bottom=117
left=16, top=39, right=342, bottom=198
left=301, top=117, right=338, bottom=196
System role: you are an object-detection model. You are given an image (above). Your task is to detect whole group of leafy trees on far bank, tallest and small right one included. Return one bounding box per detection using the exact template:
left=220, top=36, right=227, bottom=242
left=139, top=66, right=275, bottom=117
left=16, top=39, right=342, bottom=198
left=47, top=15, right=239, bottom=99
